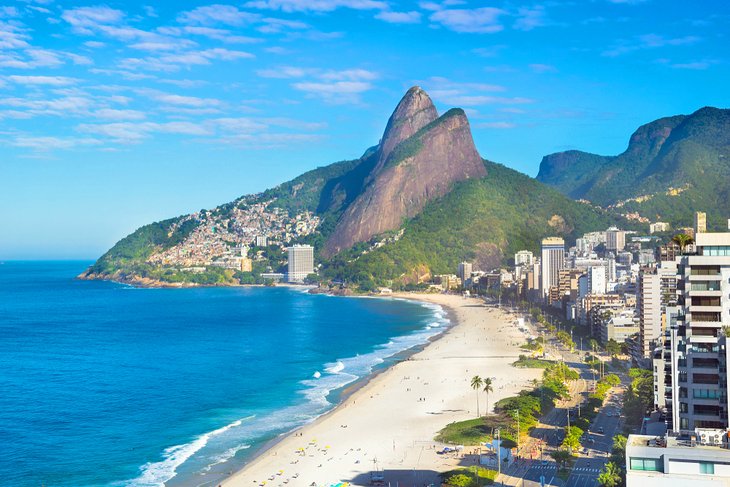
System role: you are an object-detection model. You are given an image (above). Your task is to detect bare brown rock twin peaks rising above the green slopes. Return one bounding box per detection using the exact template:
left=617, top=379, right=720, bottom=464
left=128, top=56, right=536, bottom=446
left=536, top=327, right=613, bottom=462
left=324, top=87, right=486, bottom=257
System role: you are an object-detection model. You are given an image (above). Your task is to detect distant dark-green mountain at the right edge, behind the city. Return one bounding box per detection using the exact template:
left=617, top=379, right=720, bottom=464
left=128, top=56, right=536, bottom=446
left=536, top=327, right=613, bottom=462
left=537, top=107, right=730, bottom=227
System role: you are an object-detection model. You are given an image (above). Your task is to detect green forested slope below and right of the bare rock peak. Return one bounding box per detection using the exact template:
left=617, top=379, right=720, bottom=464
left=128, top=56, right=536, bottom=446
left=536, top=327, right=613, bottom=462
left=324, top=161, right=632, bottom=287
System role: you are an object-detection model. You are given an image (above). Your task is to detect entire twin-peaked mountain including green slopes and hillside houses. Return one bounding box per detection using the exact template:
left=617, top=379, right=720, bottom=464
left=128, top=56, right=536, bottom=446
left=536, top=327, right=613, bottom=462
left=80, top=87, right=629, bottom=289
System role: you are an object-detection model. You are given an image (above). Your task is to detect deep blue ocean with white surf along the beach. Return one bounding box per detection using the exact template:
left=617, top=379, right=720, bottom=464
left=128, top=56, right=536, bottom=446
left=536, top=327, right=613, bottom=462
left=0, top=262, right=448, bottom=487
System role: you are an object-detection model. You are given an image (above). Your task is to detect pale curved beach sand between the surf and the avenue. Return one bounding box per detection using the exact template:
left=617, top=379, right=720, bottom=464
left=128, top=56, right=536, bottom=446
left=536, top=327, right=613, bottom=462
left=222, top=294, right=542, bottom=487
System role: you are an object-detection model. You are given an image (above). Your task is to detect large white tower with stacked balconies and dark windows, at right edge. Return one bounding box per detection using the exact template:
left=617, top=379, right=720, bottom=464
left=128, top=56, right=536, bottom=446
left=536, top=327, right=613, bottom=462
left=655, top=232, right=730, bottom=432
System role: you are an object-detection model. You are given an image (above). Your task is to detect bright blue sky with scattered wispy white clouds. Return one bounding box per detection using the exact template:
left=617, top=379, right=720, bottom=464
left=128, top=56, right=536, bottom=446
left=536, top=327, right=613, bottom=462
left=0, top=0, right=730, bottom=260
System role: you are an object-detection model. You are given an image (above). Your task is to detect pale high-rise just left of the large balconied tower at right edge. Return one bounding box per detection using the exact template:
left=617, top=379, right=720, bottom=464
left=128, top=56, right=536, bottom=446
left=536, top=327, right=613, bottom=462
left=636, top=262, right=677, bottom=358
